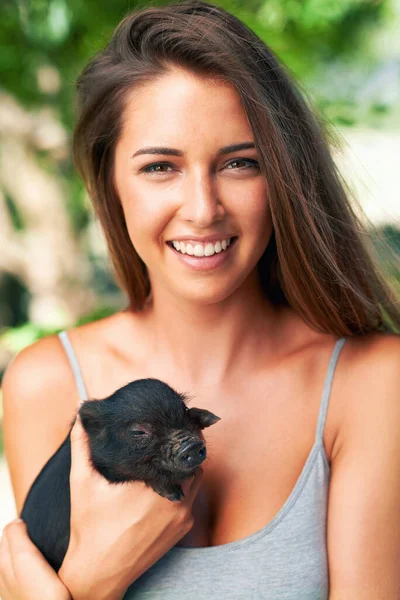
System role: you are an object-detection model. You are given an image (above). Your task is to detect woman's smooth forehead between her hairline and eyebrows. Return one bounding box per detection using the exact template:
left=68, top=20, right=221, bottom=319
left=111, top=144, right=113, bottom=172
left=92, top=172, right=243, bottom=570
left=117, top=69, right=252, bottom=154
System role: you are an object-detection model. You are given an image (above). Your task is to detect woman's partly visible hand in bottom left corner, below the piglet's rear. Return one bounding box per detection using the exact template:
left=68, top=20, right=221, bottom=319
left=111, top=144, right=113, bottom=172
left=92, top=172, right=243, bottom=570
left=0, top=521, right=71, bottom=600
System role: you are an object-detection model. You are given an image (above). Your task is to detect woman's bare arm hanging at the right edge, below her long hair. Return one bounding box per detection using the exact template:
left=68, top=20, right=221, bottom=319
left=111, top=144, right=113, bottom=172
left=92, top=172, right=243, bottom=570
left=327, top=334, right=400, bottom=600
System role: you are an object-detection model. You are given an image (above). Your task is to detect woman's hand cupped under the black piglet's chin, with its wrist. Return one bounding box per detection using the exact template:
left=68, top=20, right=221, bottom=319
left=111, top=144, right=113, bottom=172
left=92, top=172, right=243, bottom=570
left=58, top=417, right=203, bottom=600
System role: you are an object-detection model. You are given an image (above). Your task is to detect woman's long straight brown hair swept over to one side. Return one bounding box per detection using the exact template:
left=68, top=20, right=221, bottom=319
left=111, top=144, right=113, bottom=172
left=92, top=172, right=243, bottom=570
left=73, top=0, right=400, bottom=336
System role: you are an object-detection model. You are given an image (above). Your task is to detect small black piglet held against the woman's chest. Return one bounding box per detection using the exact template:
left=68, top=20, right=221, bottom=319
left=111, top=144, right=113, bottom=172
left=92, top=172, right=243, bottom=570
left=21, top=379, right=219, bottom=571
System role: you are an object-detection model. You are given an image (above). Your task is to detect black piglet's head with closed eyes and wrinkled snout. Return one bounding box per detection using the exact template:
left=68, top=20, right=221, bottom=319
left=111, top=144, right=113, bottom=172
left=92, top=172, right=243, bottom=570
left=79, top=378, right=220, bottom=481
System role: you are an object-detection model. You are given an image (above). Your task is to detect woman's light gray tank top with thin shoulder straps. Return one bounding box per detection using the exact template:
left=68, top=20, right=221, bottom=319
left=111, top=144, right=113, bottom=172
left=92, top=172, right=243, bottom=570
left=59, top=331, right=346, bottom=600
